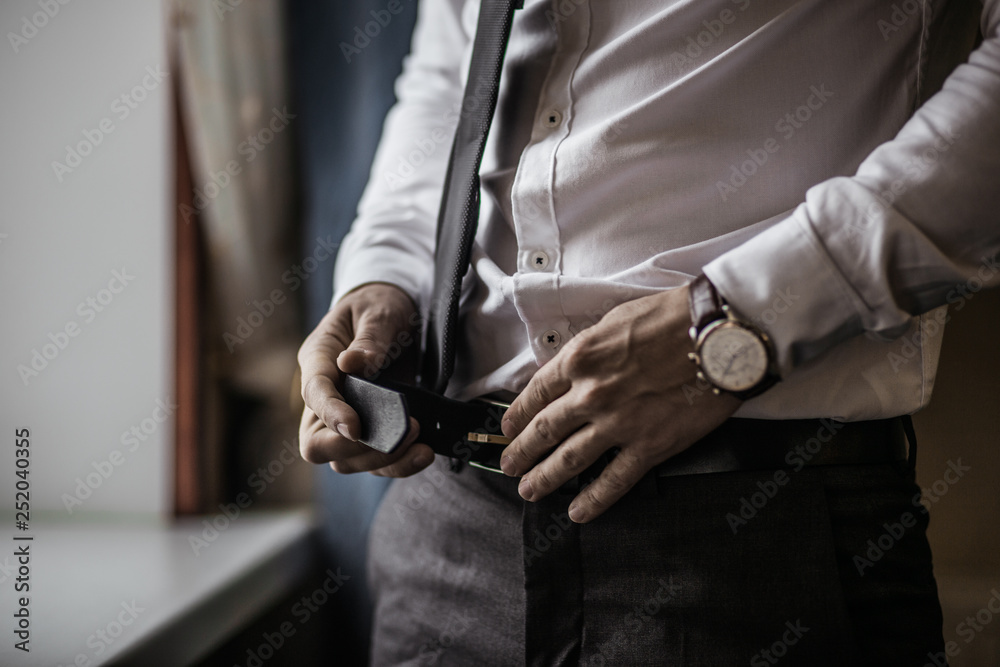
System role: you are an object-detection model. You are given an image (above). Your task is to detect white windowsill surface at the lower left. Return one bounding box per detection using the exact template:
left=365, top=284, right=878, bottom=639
left=0, top=510, right=314, bottom=667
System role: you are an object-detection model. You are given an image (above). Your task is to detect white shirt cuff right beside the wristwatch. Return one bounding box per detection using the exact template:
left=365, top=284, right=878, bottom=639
left=703, top=205, right=864, bottom=377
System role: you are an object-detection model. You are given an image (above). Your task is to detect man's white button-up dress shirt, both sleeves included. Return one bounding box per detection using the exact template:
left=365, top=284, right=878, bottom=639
left=334, top=0, right=1000, bottom=420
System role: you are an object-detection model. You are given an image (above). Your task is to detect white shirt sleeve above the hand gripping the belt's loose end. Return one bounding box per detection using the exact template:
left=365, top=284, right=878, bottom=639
left=333, top=0, right=469, bottom=304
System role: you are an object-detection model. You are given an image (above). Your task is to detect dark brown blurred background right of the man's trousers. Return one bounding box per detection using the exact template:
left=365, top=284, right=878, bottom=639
left=914, top=290, right=1000, bottom=667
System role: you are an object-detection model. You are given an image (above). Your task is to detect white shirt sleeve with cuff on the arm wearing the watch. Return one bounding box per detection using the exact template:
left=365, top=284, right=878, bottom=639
left=704, top=0, right=1000, bottom=375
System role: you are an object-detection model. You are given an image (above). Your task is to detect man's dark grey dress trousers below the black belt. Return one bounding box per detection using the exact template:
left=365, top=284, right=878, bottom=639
left=369, top=436, right=943, bottom=667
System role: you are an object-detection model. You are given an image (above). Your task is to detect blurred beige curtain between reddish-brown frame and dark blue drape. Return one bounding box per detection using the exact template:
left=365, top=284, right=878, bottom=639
left=172, top=0, right=302, bottom=511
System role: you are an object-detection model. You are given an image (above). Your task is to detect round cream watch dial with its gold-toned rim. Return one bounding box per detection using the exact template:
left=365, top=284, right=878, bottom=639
left=699, top=323, right=768, bottom=391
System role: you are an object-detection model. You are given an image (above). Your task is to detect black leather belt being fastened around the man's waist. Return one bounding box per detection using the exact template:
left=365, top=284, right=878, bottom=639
left=343, top=376, right=912, bottom=484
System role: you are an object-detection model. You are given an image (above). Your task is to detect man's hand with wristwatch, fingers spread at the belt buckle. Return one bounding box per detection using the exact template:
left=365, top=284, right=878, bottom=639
left=501, top=286, right=740, bottom=523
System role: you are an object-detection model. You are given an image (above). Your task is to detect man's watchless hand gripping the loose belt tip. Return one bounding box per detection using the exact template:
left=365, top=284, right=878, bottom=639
left=299, top=283, right=434, bottom=477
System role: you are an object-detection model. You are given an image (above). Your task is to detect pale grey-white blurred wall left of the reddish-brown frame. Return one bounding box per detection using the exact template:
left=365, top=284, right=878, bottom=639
left=0, top=0, right=173, bottom=520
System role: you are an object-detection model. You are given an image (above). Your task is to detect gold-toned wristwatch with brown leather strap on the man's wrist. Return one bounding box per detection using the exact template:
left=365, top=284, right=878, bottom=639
left=688, top=274, right=780, bottom=401
